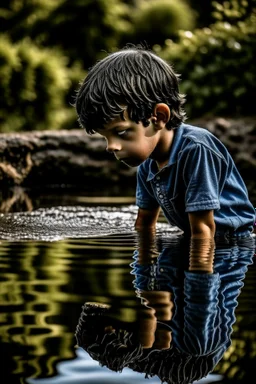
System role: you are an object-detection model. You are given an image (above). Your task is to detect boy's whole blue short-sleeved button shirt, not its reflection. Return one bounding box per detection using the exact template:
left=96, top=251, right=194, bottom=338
left=136, top=124, right=255, bottom=236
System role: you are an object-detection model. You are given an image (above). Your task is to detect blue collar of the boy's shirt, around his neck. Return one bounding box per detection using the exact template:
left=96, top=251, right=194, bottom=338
left=147, top=124, right=185, bottom=181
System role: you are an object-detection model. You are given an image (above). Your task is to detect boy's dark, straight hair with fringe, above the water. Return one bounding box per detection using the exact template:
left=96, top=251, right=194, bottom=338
left=74, top=46, right=186, bottom=134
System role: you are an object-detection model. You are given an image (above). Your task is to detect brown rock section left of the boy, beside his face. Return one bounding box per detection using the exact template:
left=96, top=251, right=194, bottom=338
left=0, top=130, right=135, bottom=189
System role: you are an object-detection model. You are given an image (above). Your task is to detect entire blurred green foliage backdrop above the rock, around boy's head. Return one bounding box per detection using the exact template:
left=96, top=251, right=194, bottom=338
left=0, top=0, right=256, bottom=132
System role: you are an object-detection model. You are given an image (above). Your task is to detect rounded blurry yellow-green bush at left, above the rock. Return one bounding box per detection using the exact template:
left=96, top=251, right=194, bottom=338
left=0, top=35, right=82, bottom=132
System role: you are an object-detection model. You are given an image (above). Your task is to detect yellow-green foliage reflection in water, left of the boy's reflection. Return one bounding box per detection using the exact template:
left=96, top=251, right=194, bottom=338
left=0, top=237, right=135, bottom=382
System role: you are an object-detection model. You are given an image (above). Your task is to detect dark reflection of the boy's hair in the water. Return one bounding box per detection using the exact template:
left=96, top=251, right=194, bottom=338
left=75, top=303, right=215, bottom=384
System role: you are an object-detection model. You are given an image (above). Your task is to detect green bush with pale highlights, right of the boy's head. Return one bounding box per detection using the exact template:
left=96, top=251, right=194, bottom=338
left=158, top=0, right=256, bottom=118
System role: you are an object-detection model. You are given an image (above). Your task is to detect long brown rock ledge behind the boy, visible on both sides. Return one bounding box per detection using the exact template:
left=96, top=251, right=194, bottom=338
left=0, top=117, right=256, bottom=210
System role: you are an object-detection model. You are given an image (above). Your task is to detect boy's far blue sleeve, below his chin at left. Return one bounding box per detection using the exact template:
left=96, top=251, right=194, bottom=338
left=136, top=164, right=159, bottom=210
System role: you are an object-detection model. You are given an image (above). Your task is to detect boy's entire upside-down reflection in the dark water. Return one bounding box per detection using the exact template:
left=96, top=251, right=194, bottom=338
left=76, top=232, right=255, bottom=383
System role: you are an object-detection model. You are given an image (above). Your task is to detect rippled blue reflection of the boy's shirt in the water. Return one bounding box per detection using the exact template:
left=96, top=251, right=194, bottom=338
left=131, top=237, right=255, bottom=367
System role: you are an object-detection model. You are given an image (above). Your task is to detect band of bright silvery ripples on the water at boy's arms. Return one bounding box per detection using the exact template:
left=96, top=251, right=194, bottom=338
left=0, top=205, right=180, bottom=241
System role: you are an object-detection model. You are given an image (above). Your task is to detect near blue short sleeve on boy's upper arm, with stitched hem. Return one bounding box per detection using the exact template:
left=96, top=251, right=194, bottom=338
left=183, top=143, right=227, bottom=212
